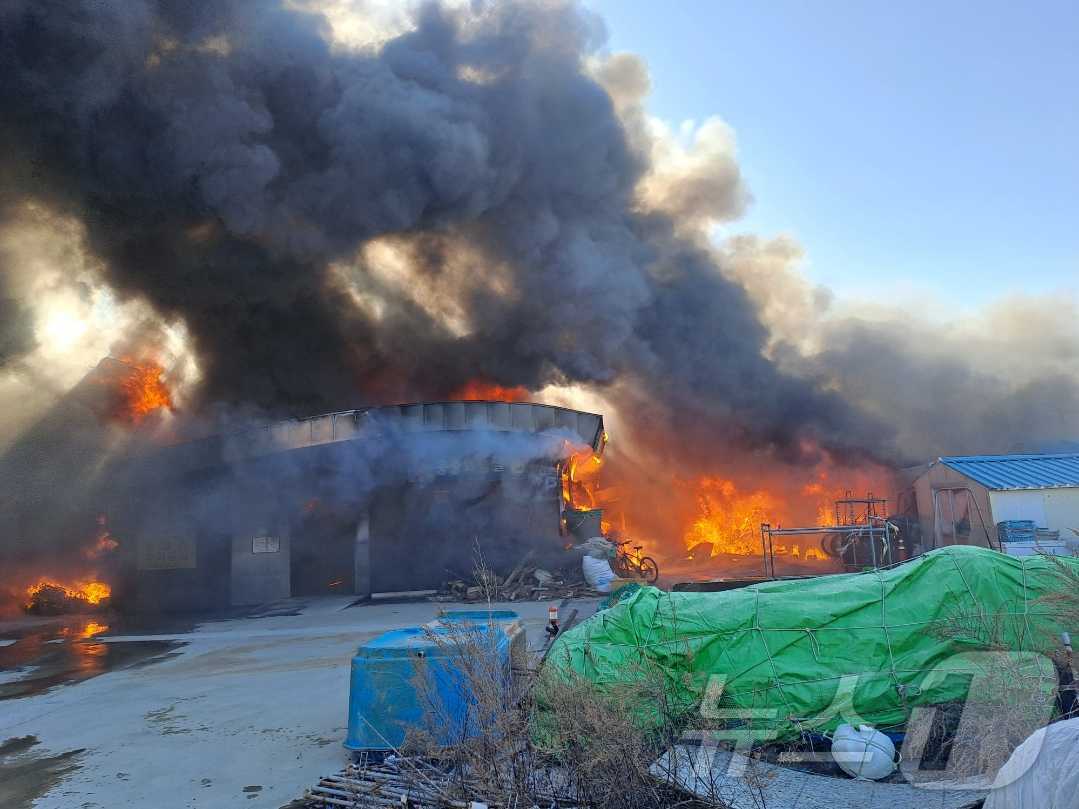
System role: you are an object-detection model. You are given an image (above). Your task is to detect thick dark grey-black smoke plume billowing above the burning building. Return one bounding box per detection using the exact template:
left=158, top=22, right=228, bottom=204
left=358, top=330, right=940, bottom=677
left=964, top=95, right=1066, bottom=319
left=0, top=0, right=882, bottom=465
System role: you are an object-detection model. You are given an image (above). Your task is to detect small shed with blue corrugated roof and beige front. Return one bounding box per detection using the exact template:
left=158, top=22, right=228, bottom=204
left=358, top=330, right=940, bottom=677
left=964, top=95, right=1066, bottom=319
left=914, top=452, right=1079, bottom=549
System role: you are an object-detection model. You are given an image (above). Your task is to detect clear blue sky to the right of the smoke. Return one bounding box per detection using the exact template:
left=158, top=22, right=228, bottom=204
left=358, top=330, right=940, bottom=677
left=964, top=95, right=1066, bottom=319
left=588, top=0, right=1079, bottom=306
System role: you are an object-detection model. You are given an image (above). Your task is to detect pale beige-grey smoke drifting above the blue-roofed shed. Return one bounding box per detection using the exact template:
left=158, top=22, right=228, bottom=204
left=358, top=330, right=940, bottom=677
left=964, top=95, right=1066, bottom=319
left=718, top=236, right=1079, bottom=464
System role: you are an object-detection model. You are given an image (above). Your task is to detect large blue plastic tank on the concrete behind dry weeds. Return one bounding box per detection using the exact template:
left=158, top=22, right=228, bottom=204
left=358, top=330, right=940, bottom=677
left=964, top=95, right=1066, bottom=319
left=344, top=625, right=514, bottom=751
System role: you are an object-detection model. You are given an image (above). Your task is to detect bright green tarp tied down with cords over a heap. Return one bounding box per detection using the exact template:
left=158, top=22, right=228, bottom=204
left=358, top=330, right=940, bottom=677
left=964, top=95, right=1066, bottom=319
left=547, top=546, right=1079, bottom=738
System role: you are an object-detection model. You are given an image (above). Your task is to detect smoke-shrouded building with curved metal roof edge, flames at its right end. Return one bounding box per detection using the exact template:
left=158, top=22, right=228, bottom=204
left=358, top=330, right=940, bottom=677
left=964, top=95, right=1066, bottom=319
left=115, top=401, right=604, bottom=609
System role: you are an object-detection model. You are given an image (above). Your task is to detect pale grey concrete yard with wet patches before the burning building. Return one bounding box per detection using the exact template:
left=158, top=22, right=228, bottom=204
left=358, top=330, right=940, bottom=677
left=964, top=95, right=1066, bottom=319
left=0, top=597, right=598, bottom=809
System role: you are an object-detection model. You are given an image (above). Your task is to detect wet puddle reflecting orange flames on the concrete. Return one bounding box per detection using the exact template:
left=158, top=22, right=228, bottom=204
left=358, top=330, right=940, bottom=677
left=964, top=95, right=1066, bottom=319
left=0, top=618, right=183, bottom=700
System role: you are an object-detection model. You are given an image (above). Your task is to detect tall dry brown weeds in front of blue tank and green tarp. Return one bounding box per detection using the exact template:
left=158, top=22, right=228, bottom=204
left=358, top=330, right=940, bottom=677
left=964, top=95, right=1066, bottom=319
left=405, top=612, right=714, bottom=809
